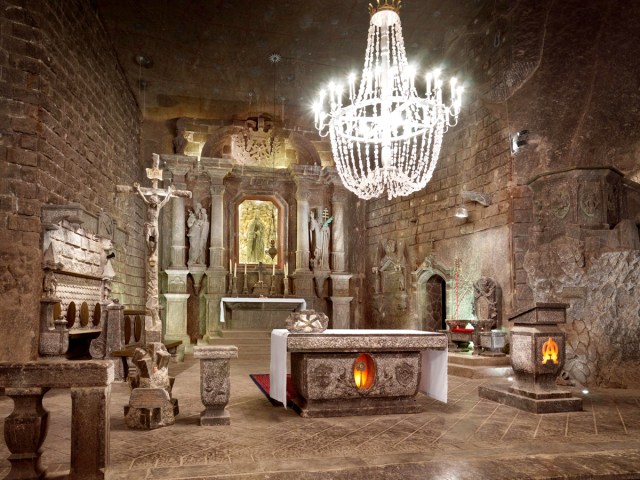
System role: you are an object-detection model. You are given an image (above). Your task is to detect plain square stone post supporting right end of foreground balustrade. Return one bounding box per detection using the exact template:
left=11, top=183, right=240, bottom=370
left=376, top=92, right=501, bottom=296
left=69, top=386, right=111, bottom=480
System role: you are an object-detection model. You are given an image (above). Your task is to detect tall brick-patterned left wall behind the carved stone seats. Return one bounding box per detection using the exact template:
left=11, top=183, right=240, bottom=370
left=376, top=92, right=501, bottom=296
left=0, top=0, right=144, bottom=361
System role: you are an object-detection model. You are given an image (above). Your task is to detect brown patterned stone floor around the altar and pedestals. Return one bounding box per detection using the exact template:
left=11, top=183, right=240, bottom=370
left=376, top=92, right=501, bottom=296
left=0, top=356, right=640, bottom=480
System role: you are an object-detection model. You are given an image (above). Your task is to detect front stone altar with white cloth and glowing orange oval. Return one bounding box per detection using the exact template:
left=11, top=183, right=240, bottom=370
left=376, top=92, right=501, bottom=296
left=270, top=329, right=448, bottom=417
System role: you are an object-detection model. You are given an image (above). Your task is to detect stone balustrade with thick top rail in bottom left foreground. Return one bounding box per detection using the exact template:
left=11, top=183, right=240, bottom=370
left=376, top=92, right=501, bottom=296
left=0, top=360, right=114, bottom=480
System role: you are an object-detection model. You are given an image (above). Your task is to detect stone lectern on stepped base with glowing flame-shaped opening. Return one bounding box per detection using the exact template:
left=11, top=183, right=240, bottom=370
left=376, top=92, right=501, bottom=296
left=478, top=303, right=582, bottom=413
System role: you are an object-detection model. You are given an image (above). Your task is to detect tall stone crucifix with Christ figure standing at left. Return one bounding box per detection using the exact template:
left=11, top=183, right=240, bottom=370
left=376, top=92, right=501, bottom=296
left=116, top=153, right=191, bottom=342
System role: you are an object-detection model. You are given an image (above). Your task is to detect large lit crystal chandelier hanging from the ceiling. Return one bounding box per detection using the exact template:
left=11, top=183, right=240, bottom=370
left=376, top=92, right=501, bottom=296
left=314, top=0, right=462, bottom=199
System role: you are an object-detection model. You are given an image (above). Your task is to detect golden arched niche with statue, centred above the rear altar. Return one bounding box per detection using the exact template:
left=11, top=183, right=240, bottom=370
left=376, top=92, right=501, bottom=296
left=229, top=193, right=289, bottom=269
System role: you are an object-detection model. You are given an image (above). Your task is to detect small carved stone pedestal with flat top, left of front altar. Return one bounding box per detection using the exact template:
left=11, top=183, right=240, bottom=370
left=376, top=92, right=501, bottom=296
left=193, top=345, right=238, bottom=426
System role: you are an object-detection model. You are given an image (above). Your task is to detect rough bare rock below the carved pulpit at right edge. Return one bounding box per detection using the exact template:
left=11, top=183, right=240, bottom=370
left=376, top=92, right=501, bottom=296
left=525, top=236, right=640, bottom=387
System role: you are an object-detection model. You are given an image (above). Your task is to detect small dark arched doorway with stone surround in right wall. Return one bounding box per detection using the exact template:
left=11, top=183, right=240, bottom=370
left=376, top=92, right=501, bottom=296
left=412, top=256, right=453, bottom=330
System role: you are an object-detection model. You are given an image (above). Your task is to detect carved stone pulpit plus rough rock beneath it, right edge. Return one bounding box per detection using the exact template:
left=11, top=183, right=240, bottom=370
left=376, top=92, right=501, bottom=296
left=523, top=169, right=640, bottom=387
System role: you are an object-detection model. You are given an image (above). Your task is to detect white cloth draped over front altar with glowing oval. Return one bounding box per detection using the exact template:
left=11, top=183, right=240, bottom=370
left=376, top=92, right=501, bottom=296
left=269, top=329, right=448, bottom=408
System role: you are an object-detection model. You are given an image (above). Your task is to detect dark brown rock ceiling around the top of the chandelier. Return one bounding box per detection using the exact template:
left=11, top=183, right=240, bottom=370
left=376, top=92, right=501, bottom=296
left=94, top=0, right=487, bottom=122
